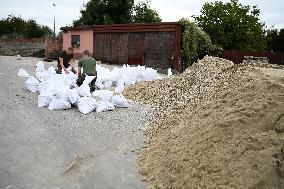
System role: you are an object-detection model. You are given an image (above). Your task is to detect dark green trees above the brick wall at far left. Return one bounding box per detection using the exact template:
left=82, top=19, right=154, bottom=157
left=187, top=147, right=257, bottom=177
left=0, top=15, right=52, bottom=38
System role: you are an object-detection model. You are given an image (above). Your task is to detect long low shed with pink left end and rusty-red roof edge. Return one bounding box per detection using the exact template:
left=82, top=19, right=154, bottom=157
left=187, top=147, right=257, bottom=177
left=61, top=22, right=182, bottom=70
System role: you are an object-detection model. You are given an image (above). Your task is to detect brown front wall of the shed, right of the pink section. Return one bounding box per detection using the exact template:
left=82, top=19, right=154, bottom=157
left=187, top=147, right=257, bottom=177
left=94, top=32, right=175, bottom=69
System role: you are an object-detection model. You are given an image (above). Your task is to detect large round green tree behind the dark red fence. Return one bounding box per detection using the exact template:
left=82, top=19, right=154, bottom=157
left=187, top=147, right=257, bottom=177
left=193, top=0, right=266, bottom=50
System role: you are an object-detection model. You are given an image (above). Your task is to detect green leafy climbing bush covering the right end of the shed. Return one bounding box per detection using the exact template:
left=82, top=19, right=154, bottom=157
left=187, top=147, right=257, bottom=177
left=179, top=18, right=217, bottom=68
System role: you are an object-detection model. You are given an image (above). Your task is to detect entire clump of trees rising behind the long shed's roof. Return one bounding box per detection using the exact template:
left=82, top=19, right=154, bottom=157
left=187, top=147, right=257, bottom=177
left=73, top=0, right=161, bottom=26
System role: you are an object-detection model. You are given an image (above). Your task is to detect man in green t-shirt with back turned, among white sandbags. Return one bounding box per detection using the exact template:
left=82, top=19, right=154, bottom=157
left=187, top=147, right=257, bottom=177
left=77, top=50, right=97, bottom=91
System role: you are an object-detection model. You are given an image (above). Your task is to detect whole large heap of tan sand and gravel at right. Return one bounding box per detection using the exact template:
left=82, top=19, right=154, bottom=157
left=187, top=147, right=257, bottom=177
left=125, top=57, right=284, bottom=188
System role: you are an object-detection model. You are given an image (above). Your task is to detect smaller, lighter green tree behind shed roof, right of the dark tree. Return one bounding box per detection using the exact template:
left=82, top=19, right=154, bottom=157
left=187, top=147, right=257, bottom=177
left=132, top=1, right=162, bottom=23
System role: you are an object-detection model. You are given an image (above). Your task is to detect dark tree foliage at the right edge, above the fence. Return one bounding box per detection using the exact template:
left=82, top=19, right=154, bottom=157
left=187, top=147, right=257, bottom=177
left=266, top=28, right=284, bottom=52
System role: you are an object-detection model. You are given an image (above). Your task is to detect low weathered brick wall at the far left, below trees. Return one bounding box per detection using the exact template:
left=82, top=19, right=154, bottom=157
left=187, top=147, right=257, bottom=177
left=0, top=38, right=45, bottom=56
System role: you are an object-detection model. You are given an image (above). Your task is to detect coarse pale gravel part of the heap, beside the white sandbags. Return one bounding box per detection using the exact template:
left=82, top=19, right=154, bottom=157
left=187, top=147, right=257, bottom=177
left=124, top=56, right=245, bottom=114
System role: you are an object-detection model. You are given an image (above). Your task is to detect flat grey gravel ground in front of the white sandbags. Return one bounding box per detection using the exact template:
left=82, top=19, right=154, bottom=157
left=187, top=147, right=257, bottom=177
left=0, top=56, right=154, bottom=189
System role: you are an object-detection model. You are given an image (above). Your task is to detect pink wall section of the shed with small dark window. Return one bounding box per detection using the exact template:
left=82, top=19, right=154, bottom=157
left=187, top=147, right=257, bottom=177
left=63, top=27, right=94, bottom=59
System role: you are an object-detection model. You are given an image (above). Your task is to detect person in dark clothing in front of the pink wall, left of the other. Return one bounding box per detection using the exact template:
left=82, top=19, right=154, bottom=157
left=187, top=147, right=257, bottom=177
left=57, top=47, right=76, bottom=74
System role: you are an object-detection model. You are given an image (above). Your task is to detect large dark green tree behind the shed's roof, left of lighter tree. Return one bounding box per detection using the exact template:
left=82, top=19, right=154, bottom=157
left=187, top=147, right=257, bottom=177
left=73, top=0, right=134, bottom=26
